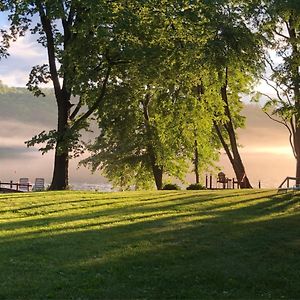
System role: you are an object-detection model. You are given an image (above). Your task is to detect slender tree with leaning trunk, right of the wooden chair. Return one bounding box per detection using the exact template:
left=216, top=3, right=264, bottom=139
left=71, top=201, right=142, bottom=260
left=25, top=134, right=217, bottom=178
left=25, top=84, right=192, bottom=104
left=191, top=1, right=262, bottom=188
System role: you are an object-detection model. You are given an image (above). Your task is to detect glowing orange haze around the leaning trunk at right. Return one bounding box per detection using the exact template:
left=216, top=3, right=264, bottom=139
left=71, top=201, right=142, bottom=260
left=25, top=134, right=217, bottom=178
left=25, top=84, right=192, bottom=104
left=216, top=105, right=296, bottom=188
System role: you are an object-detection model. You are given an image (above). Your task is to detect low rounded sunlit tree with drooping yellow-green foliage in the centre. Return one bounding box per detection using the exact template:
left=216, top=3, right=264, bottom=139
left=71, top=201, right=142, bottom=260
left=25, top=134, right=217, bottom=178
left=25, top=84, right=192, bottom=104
left=83, top=76, right=215, bottom=190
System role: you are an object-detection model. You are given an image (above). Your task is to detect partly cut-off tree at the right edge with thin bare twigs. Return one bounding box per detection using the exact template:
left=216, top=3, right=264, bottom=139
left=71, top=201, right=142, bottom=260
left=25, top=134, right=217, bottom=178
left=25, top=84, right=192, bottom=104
left=251, top=0, right=300, bottom=184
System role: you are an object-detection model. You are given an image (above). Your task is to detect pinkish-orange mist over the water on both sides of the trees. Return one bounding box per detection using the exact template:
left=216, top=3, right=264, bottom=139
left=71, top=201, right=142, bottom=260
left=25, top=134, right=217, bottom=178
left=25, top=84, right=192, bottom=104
left=0, top=102, right=295, bottom=188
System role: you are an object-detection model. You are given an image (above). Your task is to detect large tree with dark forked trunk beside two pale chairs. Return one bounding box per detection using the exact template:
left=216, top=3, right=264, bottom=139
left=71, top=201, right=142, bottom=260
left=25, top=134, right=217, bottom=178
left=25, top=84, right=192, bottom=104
left=1, top=0, right=159, bottom=190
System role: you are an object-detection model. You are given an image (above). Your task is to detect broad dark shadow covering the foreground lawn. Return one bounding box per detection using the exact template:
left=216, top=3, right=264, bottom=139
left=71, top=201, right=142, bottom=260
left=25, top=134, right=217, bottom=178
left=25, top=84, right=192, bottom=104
left=0, top=189, right=300, bottom=299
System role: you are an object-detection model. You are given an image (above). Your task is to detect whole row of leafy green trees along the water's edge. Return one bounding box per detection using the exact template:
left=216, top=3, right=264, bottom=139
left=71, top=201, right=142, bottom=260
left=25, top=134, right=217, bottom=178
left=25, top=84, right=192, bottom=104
left=0, top=0, right=292, bottom=189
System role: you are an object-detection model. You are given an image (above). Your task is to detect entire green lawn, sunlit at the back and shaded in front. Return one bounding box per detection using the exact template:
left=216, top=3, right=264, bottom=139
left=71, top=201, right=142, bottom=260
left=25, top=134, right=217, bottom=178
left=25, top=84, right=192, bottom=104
left=0, top=190, right=300, bottom=300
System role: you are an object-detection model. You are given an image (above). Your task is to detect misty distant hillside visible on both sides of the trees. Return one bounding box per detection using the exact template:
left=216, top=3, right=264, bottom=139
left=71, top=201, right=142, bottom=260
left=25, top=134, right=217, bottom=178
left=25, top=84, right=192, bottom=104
left=0, top=81, right=287, bottom=145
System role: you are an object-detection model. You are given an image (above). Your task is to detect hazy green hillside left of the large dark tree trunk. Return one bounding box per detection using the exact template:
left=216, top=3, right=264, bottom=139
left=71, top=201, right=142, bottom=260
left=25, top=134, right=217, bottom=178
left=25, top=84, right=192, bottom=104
left=0, top=84, right=56, bottom=127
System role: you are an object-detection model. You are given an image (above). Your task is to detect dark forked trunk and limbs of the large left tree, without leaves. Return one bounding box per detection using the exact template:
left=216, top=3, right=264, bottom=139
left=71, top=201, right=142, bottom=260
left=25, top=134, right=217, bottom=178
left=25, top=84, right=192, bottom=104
left=36, top=2, right=111, bottom=190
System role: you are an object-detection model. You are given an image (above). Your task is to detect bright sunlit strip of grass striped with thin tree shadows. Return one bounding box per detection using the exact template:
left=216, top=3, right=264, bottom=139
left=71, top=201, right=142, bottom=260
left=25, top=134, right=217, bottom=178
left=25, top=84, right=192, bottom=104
left=1, top=192, right=272, bottom=231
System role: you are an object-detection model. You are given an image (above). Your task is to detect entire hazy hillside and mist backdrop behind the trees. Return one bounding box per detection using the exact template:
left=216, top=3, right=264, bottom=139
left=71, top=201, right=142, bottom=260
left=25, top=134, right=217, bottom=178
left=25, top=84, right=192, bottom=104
left=0, top=83, right=295, bottom=187
